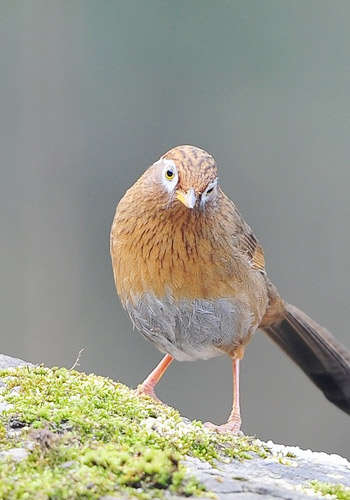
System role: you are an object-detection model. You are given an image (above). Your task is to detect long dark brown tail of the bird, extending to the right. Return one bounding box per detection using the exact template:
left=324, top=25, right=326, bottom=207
left=264, top=304, right=350, bottom=415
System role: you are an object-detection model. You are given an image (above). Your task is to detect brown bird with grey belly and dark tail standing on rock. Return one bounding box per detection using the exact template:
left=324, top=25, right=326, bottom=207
left=111, top=146, right=350, bottom=432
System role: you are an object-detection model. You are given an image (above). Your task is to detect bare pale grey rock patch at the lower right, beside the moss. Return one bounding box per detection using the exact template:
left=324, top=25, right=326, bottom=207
left=188, top=450, right=350, bottom=500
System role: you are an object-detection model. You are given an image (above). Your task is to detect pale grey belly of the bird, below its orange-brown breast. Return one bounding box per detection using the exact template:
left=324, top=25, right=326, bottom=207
left=125, top=294, right=252, bottom=361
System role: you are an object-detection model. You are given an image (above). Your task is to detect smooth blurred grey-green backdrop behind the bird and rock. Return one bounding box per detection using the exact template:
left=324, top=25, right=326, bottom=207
left=0, top=0, right=350, bottom=457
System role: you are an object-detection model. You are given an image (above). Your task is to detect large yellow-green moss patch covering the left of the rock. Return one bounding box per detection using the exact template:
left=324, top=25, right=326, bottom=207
left=0, top=367, right=266, bottom=500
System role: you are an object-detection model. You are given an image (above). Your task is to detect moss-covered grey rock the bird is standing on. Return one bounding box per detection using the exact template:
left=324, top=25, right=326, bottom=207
left=0, top=356, right=350, bottom=500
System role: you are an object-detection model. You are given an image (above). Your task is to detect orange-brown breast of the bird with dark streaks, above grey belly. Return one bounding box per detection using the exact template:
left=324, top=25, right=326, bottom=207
left=111, top=205, right=246, bottom=302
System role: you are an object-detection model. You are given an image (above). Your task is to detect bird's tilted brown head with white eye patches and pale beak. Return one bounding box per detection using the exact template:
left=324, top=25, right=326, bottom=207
left=153, top=146, right=218, bottom=210
